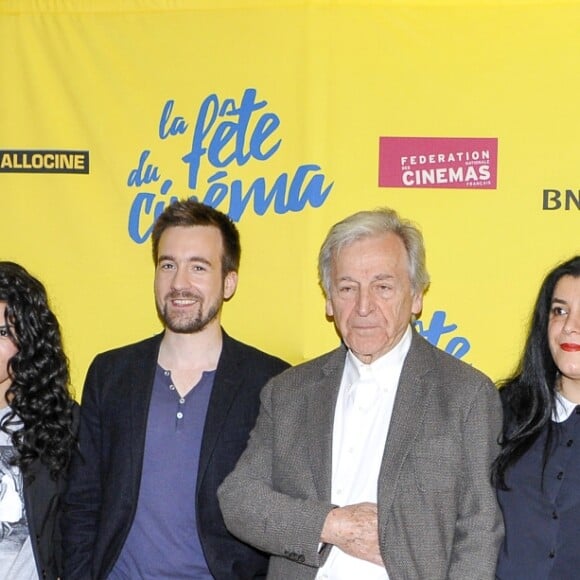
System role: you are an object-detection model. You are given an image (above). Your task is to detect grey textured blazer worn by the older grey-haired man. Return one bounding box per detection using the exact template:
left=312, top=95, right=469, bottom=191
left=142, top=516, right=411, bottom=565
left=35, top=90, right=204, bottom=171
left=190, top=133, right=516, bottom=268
left=218, top=333, right=503, bottom=580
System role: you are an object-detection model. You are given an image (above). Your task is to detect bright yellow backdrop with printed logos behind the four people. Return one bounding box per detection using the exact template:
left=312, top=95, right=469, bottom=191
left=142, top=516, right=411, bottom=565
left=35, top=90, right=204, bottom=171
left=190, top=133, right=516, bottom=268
left=0, top=0, right=580, bottom=396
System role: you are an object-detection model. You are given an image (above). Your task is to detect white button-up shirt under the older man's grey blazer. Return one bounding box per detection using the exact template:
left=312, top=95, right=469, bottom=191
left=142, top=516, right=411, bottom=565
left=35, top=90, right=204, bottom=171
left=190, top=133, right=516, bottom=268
left=316, top=326, right=412, bottom=580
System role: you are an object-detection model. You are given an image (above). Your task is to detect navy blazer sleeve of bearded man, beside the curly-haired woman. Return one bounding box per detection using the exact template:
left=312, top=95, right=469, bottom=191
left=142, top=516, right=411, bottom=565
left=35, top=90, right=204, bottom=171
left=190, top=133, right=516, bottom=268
left=61, top=357, right=106, bottom=580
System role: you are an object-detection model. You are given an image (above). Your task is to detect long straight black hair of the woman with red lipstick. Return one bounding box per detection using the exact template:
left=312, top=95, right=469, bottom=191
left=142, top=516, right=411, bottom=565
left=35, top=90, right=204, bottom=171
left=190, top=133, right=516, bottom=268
left=492, top=256, right=580, bottom=489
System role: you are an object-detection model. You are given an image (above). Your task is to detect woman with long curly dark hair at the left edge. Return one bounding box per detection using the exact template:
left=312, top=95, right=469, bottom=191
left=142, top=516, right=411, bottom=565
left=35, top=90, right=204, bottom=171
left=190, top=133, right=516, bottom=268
left=0, top=262, right=78, bottom=580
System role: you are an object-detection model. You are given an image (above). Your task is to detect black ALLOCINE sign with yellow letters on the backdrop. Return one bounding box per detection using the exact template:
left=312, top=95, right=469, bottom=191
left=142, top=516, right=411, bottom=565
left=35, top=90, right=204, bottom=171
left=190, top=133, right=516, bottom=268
left=0, top=149, right=89, bottom=173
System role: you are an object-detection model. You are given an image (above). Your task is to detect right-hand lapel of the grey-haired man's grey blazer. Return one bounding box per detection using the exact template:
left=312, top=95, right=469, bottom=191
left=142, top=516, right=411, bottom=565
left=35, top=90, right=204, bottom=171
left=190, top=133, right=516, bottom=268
left=379, top=333, right=434, bottom=513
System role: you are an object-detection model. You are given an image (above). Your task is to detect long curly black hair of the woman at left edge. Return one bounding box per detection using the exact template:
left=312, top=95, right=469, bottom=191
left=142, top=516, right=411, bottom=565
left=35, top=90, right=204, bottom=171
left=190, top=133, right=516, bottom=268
left=0, top=262, right=76, bottom=478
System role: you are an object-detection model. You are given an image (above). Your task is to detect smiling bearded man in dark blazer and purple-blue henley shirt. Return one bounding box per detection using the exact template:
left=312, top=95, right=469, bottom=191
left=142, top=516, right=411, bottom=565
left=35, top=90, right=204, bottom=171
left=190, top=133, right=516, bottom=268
left=63, top=200, right=288, bottom=580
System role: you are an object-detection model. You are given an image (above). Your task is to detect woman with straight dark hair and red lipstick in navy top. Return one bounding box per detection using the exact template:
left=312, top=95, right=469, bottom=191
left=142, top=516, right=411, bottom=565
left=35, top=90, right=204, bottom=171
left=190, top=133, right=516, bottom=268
left=492, top=256, right=580, bottom=580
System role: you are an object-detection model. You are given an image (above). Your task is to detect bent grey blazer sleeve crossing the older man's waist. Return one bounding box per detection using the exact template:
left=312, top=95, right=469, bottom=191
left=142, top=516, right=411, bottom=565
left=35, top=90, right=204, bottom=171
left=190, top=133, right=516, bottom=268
left=218, top=379, right=335, bottom=567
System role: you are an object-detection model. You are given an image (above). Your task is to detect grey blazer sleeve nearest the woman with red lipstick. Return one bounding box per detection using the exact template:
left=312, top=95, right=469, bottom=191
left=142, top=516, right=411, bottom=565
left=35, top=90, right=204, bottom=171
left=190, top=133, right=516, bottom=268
left=447, top=380, right=503, bottom=580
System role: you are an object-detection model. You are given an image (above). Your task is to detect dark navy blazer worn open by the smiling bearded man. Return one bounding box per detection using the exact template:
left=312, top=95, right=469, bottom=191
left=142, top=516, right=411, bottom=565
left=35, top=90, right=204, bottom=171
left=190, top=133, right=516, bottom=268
left=62, top=333, right=288, bottom=580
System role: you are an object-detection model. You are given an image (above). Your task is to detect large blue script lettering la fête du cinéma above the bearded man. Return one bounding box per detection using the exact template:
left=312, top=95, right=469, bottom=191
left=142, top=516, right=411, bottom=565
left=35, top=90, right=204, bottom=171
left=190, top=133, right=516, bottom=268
left=127, top=88, right=334, bottom=244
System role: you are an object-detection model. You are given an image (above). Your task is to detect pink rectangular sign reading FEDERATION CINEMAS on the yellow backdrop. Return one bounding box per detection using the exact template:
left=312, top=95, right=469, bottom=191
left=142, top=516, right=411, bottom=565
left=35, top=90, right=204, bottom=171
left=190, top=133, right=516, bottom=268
left=379, top=137, right=497, bottom=189
